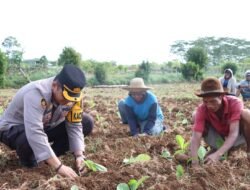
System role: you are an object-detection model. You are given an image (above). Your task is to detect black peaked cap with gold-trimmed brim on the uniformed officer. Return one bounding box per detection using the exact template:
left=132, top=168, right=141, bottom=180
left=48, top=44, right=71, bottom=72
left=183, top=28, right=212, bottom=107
left=55, top=64, right=86, bottom=102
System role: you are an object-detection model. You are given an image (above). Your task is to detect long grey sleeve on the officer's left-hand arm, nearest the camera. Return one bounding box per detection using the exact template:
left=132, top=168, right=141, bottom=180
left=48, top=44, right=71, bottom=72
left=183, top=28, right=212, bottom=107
left=24, top=90, right=55, bottom=162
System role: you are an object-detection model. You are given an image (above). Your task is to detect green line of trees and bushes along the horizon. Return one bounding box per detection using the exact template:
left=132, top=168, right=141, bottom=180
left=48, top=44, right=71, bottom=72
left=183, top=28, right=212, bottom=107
left=0, top=36, right=250, bottom=88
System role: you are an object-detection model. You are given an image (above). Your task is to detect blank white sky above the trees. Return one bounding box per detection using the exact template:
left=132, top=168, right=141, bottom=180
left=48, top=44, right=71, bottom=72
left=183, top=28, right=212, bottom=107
left=0, top=0, right=250, bottom=64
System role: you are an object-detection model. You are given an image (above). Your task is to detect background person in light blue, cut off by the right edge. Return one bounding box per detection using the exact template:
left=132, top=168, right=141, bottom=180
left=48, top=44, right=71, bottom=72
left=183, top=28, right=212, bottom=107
left=236, top=70, right=250, bottom=101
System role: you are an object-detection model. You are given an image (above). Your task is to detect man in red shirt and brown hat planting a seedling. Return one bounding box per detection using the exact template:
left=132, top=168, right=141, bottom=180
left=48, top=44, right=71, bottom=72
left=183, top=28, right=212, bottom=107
left=191, top=77, right=250, bottom=165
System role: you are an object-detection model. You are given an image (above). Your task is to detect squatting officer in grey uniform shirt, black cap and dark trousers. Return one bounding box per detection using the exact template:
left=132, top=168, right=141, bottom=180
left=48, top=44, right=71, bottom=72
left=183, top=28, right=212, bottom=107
left=0, top=65, right=93, bottom=178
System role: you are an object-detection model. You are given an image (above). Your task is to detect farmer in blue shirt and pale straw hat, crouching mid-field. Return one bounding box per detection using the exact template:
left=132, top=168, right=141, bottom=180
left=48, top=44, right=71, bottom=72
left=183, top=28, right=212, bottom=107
left=118, top=78, right=163, bottom=136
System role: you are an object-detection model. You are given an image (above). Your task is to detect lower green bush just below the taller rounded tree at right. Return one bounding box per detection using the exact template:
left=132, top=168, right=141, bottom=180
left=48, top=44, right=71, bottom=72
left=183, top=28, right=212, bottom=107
left=181, top=62, right=203, bottom=80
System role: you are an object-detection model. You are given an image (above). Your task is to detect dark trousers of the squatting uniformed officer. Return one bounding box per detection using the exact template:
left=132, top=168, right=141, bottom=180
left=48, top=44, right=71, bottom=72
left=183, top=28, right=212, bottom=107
left=0, top=114, right=94, bottom=167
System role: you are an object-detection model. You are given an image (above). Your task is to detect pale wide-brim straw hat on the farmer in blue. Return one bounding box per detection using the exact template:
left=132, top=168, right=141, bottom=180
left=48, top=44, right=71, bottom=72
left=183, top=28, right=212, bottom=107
left=123, top=78, right=152, bottom=92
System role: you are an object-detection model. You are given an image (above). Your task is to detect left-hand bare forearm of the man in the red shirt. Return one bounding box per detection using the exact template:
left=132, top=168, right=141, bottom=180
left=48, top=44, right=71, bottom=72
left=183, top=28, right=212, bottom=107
left=190, top=131, right=202, bottom=164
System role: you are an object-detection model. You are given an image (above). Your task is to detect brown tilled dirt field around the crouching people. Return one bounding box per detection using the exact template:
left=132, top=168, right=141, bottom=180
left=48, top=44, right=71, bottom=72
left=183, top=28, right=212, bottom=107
left=0, top=86, right=250, bottom=190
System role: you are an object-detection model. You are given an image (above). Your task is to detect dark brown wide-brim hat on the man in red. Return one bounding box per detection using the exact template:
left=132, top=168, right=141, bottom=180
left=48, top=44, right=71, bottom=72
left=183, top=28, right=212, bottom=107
left=195, top=77, right=227, bottom=97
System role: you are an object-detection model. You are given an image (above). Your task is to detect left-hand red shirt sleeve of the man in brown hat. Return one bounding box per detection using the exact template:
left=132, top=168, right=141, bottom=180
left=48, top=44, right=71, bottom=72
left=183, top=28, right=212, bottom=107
left=192, top=105, right=205, bottom=133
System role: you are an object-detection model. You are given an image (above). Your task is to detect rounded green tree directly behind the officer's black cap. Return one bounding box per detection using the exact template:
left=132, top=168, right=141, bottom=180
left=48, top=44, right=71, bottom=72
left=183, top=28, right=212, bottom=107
left=58, top=47, right=81, bottom=67
